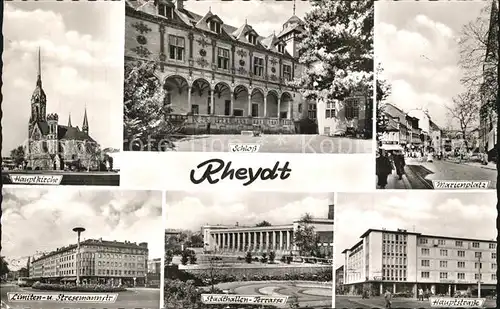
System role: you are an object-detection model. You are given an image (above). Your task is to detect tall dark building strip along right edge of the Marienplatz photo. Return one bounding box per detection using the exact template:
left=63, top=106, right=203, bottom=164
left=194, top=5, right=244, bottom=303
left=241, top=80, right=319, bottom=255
left=479, top=0, right=500, bottom=161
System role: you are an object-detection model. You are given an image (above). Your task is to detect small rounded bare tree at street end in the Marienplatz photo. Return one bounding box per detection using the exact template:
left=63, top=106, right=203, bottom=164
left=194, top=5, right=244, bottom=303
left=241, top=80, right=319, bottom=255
left=446, top=89, right=480, bottom=147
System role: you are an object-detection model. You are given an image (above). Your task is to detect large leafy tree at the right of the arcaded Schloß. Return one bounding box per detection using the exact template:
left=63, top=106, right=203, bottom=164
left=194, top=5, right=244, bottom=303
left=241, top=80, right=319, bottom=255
left=291, top=0, right=374, bottom=101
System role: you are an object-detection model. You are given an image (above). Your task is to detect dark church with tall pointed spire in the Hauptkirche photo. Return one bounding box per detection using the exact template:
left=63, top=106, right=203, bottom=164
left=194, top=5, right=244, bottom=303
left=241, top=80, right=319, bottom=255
left=25, top=49, right=100, bottom=170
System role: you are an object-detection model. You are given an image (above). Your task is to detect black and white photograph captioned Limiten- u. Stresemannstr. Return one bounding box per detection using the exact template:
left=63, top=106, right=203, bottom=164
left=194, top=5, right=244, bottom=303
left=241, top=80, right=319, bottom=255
left=0, top=187, right=164, bottom=309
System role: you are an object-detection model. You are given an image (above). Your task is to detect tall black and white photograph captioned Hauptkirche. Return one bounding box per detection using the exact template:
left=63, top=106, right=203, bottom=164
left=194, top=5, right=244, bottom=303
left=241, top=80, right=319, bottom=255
left=2, top=1, right=124, bottom=186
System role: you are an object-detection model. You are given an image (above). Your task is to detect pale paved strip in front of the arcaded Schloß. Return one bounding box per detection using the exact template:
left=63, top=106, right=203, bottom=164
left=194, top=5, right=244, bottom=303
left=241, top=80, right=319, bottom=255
left=175, top=135, right=373, bottom=153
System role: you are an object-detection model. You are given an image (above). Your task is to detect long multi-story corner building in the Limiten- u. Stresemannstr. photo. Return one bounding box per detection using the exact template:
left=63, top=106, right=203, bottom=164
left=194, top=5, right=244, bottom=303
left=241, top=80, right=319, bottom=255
left=29, top=239, right=148, bottom=286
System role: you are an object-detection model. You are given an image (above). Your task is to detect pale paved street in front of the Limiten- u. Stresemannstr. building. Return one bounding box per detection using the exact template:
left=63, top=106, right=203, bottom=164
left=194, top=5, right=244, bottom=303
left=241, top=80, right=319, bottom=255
left=0, top=285, right=160, bottom=309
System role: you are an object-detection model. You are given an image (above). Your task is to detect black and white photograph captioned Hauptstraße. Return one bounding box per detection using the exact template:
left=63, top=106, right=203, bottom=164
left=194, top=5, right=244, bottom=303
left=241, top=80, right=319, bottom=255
left=335, top=191, right=497, bottom=309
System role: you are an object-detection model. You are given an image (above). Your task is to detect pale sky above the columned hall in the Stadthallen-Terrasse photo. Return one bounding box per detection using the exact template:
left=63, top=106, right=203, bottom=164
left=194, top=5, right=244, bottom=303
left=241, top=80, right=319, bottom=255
left=165, top=191, right=333, bottom=232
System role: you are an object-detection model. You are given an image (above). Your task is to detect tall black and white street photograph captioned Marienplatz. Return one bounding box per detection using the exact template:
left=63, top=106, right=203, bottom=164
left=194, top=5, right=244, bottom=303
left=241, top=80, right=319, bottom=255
left=375, top=0, right=500, bottom=189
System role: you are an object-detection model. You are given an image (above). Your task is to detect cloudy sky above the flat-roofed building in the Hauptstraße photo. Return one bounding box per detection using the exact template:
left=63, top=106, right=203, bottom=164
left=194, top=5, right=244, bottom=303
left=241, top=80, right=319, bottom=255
left=335, top=191, right=497, bottom=268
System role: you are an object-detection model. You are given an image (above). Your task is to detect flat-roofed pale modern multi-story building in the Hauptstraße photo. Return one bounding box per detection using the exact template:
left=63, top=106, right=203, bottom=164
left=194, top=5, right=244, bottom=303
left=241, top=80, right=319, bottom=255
left=343, top=229, right=497, bottom=296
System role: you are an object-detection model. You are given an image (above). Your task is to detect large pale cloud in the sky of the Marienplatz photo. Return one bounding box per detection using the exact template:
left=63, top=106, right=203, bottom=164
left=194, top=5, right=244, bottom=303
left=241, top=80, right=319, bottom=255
left=375, top=14, right=463, bottom=126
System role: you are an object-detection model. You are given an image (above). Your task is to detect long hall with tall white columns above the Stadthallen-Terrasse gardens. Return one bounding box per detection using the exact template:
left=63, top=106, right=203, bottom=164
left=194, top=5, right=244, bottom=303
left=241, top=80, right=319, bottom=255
left=201, top=205, right=334, bottom=257
